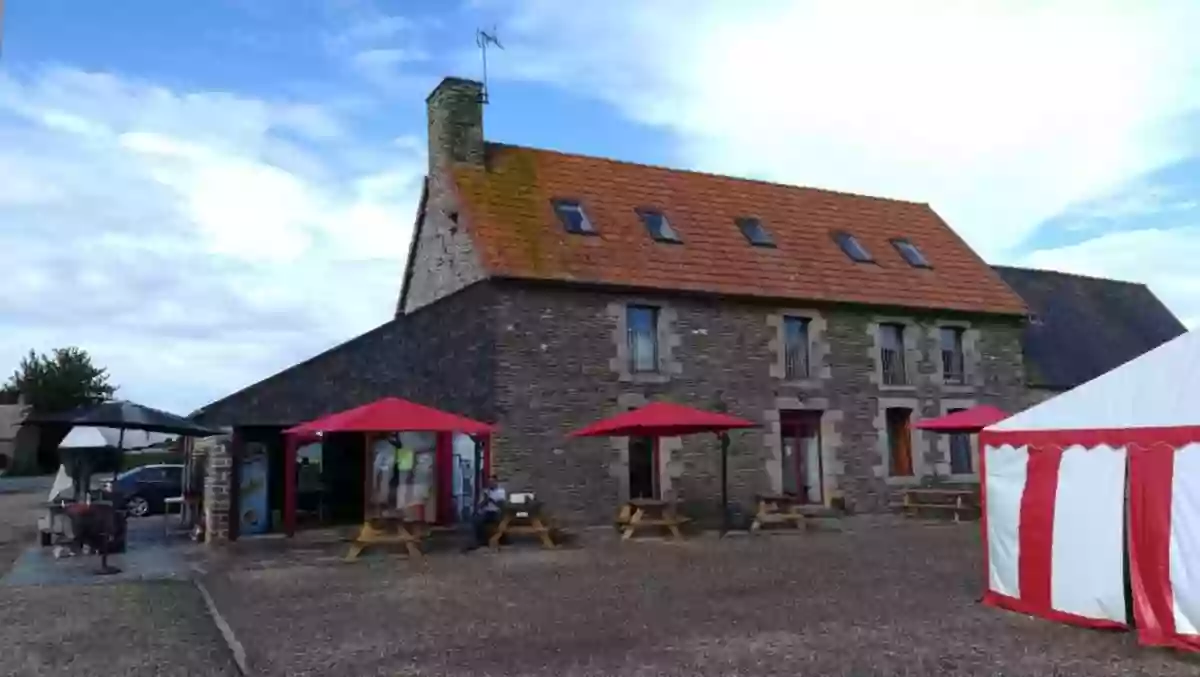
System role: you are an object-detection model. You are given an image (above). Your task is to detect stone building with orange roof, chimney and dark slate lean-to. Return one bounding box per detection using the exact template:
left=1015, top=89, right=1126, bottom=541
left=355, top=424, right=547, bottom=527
left=196, top=78, right=1027, bottom=535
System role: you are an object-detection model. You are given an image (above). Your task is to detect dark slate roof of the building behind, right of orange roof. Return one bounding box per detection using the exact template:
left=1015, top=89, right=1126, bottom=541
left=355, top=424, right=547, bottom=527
left=994, top=265, right=1187, bottom=389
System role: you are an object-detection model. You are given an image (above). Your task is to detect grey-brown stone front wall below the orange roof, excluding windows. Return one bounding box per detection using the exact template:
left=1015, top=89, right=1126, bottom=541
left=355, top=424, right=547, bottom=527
left=494, top=283, right=1025, bottom=522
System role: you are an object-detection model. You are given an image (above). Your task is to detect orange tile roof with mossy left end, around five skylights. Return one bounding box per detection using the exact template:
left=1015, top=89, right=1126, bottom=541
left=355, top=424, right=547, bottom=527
left=452, top=144, right=1026, bottom=314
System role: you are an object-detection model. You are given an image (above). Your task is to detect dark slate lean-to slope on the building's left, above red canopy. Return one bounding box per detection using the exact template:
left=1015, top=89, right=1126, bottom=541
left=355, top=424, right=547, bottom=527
left=191, top=282, right=496, bottom=426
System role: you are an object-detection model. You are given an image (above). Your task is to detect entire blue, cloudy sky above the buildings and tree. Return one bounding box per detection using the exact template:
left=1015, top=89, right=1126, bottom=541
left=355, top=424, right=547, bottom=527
left=0, top=0, right=1200, bottom=413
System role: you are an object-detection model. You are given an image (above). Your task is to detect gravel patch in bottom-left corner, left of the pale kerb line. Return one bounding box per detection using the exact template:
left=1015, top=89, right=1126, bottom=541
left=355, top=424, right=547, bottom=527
left=0, top=582, right=238, bottom=677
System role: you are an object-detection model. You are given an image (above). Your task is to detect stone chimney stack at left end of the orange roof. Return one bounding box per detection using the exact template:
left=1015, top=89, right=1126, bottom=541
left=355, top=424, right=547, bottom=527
left=425, top=78, right=484, bottom=173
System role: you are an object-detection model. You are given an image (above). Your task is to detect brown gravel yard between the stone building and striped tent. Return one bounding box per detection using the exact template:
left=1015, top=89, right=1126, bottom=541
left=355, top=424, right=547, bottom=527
left=209, top=520, right=1200, bottom=677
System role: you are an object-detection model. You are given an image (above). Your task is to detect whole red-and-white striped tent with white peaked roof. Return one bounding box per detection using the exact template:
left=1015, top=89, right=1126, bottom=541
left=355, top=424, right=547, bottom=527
left=979, top=331, right=1200, bottom=651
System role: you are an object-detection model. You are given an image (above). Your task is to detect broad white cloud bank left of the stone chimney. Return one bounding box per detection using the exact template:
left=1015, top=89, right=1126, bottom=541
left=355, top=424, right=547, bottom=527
left=0, top=68, right=425, bottom=412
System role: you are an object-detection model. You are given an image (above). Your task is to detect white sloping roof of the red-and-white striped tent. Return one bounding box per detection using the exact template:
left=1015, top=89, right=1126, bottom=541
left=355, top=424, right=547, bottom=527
left=986, top=331, right=1200, bottom=432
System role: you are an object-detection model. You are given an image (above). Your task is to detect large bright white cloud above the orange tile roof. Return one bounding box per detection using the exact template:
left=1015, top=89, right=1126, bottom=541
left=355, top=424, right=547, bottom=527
left=480, top=0, right=1200, bottom=259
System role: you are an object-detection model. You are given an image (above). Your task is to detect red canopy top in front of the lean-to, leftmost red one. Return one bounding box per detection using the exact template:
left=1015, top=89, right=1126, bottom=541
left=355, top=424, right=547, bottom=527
left=284, top=397, right=496, bottom=436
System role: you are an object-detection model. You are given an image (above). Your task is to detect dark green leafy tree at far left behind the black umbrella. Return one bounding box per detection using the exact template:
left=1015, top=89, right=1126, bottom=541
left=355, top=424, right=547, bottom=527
left=2, top=347, right=116, bottom=413
